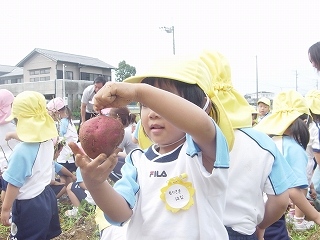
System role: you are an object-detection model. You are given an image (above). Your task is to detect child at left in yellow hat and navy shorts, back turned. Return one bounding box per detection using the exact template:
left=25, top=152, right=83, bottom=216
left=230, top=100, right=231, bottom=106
left=1, top=91, right=61, bottom=240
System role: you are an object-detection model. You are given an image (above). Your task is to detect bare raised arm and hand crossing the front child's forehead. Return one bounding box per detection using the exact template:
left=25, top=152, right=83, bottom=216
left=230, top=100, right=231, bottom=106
left=95, top=82, right=216, bottom=157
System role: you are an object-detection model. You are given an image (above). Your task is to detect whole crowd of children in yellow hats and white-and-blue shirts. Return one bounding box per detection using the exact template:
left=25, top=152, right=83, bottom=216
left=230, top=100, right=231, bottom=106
left=0, top=42, right=320, bottom=240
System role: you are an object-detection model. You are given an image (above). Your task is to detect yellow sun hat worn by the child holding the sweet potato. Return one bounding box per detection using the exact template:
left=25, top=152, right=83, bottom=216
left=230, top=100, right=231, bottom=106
left=124, top=55, right=234, bottom=150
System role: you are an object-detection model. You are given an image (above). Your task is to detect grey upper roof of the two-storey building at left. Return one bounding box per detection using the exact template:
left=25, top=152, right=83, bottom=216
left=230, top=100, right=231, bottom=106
left=16, top=48, right=115, bottom=69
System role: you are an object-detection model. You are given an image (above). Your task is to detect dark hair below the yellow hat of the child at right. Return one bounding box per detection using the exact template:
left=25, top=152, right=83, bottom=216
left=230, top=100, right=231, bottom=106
left=289, top=114, right=310, bottom=149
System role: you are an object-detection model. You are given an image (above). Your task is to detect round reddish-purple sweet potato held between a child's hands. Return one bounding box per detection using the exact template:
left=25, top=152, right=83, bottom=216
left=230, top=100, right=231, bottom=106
left=79, top=115, right=124, bottom=159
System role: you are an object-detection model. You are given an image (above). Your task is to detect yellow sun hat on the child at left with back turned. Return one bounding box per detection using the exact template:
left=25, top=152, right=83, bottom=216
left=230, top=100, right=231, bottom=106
left=6, top=91, right=58, bottom=142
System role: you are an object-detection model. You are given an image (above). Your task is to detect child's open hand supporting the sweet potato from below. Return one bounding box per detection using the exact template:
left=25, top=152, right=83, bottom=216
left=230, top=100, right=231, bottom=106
left=69, top=142, right=118, bottom=189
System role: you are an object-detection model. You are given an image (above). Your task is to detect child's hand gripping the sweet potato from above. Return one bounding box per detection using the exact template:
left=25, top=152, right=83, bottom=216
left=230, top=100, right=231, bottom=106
left=94, top=82, right=136, bottom=112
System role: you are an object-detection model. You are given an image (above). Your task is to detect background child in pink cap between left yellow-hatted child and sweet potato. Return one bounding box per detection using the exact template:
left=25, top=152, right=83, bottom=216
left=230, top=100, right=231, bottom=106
left=47, top=97, right=78, bottom=185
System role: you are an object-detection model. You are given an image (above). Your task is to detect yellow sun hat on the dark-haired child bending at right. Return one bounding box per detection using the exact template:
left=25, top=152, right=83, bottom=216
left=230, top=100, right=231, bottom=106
left=254, top=90, right=310, bottom=136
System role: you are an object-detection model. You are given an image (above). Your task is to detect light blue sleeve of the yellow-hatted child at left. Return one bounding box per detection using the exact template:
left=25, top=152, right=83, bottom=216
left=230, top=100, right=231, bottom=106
left=2, top=142, right=40, bottom=188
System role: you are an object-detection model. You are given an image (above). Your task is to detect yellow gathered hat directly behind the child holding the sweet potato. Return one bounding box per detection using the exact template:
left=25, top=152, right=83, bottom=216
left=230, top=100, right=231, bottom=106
left=200, top=50, right=252, bottom=129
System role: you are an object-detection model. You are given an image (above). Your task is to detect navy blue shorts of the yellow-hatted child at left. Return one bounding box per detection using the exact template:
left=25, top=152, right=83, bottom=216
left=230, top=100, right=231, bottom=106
left=10, top=186, right=61, bottom=240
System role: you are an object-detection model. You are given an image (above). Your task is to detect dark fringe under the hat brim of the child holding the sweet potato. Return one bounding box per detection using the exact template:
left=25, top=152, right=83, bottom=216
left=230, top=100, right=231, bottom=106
left=142, top=77, right=218, bottom=123
